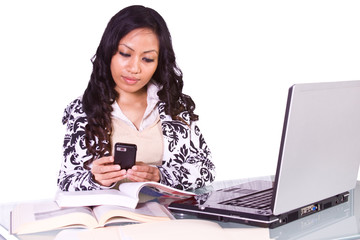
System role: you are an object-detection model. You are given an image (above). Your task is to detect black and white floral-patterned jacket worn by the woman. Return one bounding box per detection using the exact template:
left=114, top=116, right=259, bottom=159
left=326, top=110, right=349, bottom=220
left=58, top=98, right=215, bottom=191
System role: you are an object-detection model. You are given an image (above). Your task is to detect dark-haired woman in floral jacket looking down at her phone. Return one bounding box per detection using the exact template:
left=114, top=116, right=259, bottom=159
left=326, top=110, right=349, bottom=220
left=58, top=6, right=215, bottom=191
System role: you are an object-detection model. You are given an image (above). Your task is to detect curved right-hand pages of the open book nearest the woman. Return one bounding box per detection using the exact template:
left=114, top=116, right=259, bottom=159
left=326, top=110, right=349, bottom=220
left=119, top=182, right=196, bottom=199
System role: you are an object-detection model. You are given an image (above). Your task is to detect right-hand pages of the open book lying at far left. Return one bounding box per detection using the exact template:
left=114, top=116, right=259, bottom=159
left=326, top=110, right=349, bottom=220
left=93, top=202, right=173, bottom=226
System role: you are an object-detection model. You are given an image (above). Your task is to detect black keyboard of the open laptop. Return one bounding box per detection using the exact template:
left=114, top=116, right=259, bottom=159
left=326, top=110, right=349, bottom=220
left=220, top=189, right=273, bottom=210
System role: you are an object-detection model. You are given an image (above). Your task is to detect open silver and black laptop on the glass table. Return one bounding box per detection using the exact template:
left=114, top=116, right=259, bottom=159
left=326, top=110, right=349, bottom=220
left=169, top=81, right=360, bottom=228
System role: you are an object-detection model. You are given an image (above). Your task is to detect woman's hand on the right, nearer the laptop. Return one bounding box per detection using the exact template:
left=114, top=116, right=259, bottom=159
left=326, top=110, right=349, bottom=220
left=126, top=162, right=160, bottom=182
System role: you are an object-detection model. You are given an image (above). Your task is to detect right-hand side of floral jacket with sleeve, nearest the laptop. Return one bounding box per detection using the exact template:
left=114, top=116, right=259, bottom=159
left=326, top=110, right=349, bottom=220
left=159, top=102, right=215, bottom=190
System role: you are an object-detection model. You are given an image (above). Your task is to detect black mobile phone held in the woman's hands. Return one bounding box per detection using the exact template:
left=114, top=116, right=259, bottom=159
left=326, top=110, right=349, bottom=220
left=114, top=142, right=137, bottom=170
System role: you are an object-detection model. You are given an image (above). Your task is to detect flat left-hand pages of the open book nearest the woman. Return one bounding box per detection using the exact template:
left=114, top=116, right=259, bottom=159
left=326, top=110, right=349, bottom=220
left=55, top=189, right=138, bottom=208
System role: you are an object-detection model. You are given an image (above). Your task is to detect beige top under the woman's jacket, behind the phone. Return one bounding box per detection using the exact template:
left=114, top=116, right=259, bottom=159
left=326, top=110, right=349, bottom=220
left=111, top=117, right=164, bottom=166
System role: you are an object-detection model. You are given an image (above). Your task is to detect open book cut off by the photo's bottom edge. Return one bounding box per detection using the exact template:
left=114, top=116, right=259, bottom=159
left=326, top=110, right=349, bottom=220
left=60, top=219, right=270, bottom=240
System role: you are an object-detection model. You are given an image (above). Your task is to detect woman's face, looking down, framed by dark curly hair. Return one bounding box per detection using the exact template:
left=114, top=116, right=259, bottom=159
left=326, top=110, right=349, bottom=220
left=110, top=28, right=159, bottom=94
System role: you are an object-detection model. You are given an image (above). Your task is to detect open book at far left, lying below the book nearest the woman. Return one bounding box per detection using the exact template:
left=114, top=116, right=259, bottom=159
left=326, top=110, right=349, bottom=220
left=11, top=201, right=173, bottom=234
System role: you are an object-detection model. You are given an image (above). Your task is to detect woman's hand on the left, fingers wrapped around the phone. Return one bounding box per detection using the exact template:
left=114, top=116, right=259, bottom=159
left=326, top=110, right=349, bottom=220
left=91, top=156, right=126, bottom=187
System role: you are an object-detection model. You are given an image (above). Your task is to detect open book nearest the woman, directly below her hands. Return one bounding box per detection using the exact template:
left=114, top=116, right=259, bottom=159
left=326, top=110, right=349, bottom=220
left=55, top=182, right=196, bottom=208
